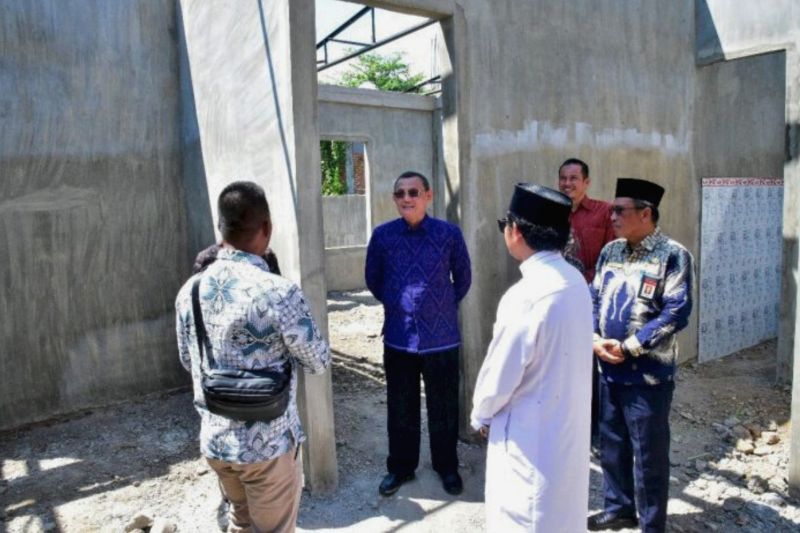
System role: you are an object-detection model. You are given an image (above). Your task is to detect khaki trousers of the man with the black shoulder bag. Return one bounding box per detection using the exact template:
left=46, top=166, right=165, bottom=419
left=206, top=450, right=303, bottom=533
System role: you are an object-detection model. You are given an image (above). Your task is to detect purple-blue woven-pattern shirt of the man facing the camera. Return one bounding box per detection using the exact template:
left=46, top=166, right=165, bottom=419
left=364, top=212, right=472, bottom=354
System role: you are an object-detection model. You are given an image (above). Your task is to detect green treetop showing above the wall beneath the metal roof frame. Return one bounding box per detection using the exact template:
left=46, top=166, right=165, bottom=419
left=341, top=53, right=424, bottom=92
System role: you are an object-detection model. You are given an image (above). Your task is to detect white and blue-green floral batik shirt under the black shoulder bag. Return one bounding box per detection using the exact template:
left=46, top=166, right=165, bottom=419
left=175, top=248, right=331, bottom=463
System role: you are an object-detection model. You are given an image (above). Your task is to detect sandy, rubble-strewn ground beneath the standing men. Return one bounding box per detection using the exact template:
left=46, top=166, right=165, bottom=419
left=0, top=292, right=800, bottom=532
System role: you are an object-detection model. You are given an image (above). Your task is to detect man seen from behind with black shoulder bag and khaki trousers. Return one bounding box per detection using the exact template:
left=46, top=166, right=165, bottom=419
left=175, top=181, right=330, bottom=531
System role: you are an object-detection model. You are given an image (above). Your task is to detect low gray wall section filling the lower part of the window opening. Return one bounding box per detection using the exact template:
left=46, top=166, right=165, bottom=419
left=322, top=194, right=367, bottom=248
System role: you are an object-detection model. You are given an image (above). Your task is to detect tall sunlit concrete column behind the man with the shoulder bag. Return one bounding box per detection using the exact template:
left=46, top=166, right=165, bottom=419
left=179, top=0, right=337, bottom=492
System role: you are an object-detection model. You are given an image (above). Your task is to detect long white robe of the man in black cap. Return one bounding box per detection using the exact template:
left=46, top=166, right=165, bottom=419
left=471, top=252, right=592, bottom=533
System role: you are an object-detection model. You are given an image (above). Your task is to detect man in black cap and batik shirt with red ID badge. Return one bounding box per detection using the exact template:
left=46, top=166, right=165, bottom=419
left=588, top=178, right=694, bottom=533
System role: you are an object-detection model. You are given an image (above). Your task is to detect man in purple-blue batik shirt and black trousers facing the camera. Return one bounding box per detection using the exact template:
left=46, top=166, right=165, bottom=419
left=365, top=172, right=472, bottom=496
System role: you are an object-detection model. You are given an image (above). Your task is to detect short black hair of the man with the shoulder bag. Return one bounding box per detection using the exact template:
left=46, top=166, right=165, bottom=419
left=217, top=181, right=270, bottom=244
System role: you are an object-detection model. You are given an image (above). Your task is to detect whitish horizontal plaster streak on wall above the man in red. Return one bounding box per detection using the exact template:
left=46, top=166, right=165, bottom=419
left=475, top=120, right=691, bottom=158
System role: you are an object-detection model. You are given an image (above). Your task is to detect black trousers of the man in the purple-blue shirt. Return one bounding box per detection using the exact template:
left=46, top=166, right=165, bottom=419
left=383, top=346, right=458, bottom=476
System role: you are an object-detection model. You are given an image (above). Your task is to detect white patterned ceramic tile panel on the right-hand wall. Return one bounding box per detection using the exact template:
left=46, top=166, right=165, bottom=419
left=698, top=178, right=783, bottom=362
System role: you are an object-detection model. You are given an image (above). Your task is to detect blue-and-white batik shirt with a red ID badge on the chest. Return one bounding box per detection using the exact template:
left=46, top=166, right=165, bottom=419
left=591, top=228, right=694, bottom=385
